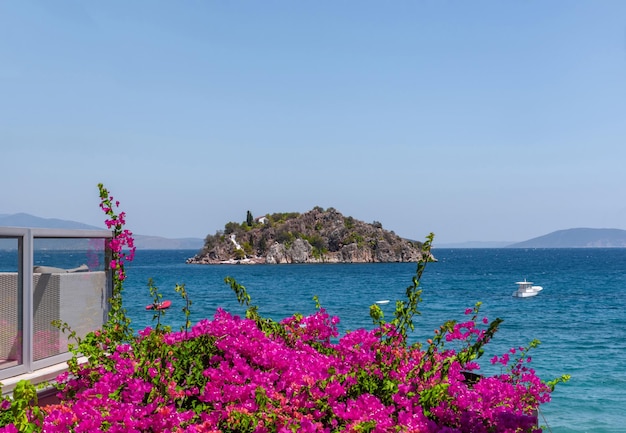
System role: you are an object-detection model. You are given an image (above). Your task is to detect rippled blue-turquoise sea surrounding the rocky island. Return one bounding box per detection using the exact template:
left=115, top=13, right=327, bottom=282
left=0, top=248, right=626, bottom=433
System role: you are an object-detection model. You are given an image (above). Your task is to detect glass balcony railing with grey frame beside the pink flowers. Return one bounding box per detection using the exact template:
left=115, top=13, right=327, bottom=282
left=0, top=227, right=112, bottom=384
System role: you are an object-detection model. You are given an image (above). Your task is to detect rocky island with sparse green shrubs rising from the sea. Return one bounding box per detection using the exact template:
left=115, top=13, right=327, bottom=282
left=187, top=206, right=422, bottom=264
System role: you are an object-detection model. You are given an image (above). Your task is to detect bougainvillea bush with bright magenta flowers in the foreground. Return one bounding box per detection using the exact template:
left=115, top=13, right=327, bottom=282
left=0, top=186, right=566, bottom=433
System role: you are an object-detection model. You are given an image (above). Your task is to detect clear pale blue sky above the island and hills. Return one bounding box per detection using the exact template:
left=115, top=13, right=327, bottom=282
left=0, top=0, right=626, bottom=244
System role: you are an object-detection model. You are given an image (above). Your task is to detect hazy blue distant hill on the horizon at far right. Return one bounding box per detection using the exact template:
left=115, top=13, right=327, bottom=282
left=508, top=228, right=626, bottom=248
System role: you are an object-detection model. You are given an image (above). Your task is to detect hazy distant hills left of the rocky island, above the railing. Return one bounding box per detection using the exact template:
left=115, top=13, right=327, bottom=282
left=0, top=213, right=204, bottom=250
